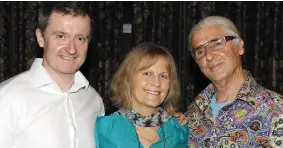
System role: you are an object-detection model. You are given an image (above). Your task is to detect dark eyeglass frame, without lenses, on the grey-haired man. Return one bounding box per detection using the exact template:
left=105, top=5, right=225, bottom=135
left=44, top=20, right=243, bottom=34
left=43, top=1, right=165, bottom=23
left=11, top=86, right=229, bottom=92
left=192, top=36, right=237, bottom=60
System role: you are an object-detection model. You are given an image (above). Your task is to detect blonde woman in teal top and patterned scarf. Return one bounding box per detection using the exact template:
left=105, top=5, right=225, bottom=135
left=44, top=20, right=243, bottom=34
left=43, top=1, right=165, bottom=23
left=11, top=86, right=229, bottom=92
left=95, top=43, right=189, bottom=148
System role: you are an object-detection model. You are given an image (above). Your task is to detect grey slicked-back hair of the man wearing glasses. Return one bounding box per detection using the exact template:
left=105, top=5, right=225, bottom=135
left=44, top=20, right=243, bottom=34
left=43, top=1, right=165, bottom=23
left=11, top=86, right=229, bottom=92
left=189, top=16, right=241, bottom=51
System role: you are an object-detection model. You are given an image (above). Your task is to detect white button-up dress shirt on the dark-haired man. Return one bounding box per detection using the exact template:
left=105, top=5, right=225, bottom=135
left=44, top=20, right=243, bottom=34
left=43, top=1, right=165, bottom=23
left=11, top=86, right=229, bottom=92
left=0, top=59, right=104, bottom=148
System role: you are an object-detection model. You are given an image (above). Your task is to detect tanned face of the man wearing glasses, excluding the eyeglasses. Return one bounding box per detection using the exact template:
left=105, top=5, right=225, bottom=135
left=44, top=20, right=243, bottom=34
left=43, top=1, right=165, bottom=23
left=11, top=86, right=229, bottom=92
left=192, top=26, right=244, bottom=83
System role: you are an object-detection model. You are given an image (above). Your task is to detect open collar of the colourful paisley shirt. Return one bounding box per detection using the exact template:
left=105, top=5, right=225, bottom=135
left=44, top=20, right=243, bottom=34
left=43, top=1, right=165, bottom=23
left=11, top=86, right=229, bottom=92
left=195, top=70, right=258, bottom=110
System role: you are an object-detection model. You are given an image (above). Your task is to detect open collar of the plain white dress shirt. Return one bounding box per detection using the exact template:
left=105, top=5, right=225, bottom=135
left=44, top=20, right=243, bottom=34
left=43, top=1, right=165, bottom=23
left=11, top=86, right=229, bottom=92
left=30, top=58, right=89, bottom=91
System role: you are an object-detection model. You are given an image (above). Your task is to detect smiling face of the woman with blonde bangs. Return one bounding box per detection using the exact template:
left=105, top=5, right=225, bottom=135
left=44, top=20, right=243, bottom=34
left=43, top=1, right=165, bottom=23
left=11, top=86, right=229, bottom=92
left=131, top=58, right=170, bottom=116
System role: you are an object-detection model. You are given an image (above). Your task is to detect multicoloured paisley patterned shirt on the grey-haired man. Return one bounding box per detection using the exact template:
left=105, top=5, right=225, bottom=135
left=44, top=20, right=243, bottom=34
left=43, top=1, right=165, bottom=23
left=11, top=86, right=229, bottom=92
left=185, top=71, right=283, bottom=148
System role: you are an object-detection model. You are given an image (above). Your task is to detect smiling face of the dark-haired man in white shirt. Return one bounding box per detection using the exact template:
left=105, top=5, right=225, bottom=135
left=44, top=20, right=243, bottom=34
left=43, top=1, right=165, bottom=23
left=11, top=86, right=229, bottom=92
left=36, top=12, right=90, bottom=75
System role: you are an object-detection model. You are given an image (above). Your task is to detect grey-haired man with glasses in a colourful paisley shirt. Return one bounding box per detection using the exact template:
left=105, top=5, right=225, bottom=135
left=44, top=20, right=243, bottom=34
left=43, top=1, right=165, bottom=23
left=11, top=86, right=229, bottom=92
left=185, top=16, right=283, bottom=148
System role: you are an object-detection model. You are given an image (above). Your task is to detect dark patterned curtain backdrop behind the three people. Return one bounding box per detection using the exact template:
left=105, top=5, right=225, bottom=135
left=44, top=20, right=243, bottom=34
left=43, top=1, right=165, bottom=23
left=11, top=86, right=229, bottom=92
left=0, top=1, right=283, bottom=114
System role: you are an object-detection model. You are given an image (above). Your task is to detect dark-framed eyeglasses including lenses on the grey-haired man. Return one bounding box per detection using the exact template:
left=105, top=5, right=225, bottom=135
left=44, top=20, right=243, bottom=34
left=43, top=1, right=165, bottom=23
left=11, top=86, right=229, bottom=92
left=192, top=36, right=237, bottom=60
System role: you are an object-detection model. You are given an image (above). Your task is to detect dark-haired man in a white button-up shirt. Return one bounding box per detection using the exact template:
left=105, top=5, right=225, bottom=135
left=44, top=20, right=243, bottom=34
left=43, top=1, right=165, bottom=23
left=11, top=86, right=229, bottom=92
left=0, top=1, right=104, bottom=148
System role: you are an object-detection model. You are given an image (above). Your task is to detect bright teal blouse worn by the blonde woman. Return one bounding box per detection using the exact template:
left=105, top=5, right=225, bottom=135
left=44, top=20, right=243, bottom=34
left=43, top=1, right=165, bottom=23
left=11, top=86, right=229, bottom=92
left=95, top=113, right=189, bottom=148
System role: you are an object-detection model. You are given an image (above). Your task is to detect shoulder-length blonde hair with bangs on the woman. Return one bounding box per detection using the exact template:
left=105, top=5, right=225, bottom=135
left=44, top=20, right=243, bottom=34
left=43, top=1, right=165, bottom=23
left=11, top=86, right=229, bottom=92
left=111, top=43, right=180, bottom=115
